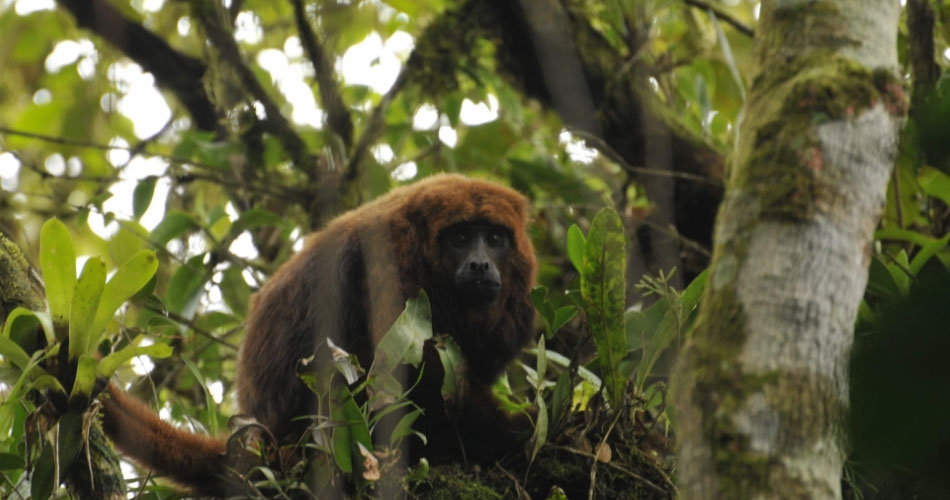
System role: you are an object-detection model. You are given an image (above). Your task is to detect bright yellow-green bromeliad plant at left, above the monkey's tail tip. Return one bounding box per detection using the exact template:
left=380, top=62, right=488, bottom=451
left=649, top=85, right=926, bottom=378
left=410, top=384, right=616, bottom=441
left=0, top=219, right=171, bottom=500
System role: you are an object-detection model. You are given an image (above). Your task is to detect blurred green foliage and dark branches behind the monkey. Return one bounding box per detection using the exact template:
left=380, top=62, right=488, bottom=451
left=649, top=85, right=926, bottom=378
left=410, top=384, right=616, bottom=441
left=0, top=0, right=950, bottom=498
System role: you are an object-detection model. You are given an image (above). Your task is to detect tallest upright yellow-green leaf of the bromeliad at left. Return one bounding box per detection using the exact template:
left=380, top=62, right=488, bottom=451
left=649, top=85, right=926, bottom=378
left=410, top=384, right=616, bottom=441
left=40, top=219, right=76, bottom=328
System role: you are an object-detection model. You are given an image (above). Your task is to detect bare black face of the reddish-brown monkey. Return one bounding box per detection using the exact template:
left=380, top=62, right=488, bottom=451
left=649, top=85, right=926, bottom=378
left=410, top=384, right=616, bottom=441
left=439, top=222, right=512, bottom=305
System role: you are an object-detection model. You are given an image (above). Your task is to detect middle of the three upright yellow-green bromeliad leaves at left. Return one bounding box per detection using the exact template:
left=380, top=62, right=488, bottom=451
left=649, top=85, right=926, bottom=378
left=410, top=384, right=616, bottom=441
left=69, top=257, right=106, bottom=360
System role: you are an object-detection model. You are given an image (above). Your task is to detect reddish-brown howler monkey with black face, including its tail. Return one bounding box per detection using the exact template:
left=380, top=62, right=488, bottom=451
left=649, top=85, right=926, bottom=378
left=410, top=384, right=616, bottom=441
left=103, top=175, right=535, bottom=494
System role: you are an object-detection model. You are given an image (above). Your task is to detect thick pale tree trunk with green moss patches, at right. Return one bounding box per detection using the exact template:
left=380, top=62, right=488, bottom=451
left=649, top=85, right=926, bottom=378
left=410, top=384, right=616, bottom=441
left=676, top=0, right=906, bottom=499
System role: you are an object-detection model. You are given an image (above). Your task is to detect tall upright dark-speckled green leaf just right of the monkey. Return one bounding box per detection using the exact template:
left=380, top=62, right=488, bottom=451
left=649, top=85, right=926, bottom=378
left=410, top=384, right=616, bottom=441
left=581, top=208, right=627, bottom=404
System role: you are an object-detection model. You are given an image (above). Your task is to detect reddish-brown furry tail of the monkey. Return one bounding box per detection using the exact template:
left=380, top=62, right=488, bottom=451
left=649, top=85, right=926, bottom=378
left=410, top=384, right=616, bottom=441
left=101, top=383, right=227, bottom=496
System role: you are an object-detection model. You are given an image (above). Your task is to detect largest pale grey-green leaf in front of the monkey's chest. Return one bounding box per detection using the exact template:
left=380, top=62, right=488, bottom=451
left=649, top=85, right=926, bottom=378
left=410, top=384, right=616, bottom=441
left=370, top=290, right=432, bottom=374
